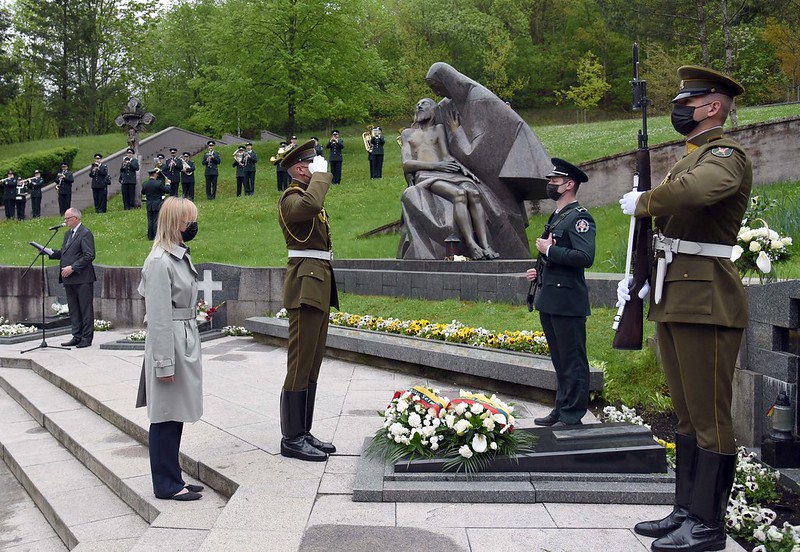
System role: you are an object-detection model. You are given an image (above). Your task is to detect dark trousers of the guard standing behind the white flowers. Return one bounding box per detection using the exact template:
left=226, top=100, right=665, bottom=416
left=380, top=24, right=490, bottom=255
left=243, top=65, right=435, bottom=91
left=539, top=312, right=589, bottom=424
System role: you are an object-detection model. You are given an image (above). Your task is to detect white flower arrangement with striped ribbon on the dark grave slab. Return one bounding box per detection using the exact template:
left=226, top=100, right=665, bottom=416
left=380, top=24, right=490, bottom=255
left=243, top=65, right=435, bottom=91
left=367, top=386, right=535, bottom=473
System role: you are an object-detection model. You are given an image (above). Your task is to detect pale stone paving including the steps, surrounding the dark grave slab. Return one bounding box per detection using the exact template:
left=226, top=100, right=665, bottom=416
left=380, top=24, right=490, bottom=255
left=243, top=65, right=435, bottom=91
left=0, top=331, right=742, bottom=552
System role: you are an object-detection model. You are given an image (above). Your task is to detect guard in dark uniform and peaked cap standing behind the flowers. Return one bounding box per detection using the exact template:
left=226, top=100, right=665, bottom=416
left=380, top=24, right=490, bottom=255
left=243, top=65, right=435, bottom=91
left=527, top=158, right=596, bottom=426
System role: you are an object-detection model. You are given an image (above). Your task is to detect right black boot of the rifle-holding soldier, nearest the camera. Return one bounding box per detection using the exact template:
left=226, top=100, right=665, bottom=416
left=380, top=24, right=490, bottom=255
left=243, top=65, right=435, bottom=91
left=650, top=448, right=736, bottom=552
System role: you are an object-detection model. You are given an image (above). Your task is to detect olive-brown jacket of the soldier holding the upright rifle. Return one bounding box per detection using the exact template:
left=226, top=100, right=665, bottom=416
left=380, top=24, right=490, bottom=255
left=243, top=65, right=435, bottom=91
left=636, top=129, right=753, bottom=328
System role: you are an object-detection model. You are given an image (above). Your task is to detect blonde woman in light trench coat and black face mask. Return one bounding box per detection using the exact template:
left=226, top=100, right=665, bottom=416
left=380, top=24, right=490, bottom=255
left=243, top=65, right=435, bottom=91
left=137, top=197, right=203, bottom=500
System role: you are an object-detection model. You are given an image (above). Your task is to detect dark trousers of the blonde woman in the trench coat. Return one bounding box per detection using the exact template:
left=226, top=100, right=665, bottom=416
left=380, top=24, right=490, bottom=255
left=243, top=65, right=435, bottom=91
left=147, top=422, right=186, bottom=498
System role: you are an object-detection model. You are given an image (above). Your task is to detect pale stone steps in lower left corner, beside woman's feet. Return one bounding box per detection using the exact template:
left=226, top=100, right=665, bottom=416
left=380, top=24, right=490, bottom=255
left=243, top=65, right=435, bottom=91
left=0, top=365, right=227, bottom=552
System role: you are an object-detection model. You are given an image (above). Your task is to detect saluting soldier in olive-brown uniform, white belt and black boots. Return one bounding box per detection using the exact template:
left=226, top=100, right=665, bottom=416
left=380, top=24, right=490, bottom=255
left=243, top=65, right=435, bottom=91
left=278, top=140, right=339, bottom=462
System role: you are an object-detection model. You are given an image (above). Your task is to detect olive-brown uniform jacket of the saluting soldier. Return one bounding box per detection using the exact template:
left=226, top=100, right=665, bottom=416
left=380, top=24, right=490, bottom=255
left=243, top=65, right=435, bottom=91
left=278, top=172, right=339, bottom=311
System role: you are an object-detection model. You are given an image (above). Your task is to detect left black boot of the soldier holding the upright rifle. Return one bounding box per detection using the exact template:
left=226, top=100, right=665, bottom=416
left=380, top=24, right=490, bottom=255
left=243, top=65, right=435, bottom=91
left=633, top=433, right=697, bottom=537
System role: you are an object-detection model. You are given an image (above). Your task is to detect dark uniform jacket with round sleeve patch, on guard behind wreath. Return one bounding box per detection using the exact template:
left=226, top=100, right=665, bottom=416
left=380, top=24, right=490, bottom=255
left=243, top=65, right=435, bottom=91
left=536, top=201, right=597, bottom=316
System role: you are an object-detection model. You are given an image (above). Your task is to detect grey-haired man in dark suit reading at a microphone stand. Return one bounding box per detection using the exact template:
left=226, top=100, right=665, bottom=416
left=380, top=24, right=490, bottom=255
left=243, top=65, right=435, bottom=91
left=44, top=208, right=97, bottom=349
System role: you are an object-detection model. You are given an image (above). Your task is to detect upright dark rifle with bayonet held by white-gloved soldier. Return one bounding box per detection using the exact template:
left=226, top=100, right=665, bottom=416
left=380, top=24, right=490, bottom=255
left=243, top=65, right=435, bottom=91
left=613, top=42, right=653, bottom=351
